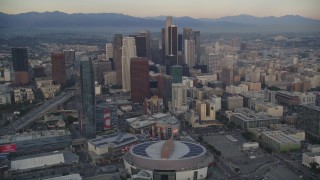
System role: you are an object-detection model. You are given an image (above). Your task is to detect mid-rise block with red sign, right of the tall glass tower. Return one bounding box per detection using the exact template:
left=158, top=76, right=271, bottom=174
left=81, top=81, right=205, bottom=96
left=95, top=103, right=119, bottom=133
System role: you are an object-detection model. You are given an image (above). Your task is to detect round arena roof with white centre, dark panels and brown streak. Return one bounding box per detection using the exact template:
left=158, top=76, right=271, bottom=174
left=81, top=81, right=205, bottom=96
left=125, top=139, right=213, bottom=170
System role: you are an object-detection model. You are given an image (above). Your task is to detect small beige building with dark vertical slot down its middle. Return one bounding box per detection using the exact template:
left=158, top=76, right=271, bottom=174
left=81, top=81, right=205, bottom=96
left=196, top=101, right=216, bottom=121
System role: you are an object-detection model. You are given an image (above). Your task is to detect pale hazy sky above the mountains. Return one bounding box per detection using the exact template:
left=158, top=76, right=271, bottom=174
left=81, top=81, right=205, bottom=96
left=0, top=0, right=320, bottom=19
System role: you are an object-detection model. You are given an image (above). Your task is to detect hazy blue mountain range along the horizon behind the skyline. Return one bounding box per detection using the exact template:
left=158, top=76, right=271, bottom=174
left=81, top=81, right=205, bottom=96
left=0, top=11, right=320, bottom=32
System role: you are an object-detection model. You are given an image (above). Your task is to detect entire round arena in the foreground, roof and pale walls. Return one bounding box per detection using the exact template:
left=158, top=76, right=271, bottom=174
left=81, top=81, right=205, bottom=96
left=123, top=139, right=213, bottom=180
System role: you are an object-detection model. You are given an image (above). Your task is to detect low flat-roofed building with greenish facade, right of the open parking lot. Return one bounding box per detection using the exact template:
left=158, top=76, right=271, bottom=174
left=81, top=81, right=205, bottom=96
left=261, top=131, right=301, bottom=152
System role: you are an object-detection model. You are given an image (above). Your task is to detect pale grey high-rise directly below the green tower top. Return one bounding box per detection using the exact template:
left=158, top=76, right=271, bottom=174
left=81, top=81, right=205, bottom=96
left=171, top=83, right=187, bottom=107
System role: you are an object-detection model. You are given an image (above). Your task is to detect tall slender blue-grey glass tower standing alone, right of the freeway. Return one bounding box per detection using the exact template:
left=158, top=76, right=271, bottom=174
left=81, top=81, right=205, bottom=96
left=80, top=57, right=96, bottom=138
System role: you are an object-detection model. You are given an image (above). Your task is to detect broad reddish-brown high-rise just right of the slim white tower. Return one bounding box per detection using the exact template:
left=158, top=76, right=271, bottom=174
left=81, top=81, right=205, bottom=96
left=130, top=57, right=150, bottom=103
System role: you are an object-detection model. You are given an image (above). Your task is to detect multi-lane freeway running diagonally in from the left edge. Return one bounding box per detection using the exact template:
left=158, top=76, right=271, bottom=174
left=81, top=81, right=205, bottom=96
left=0, top=91, right=74, bottom=136
